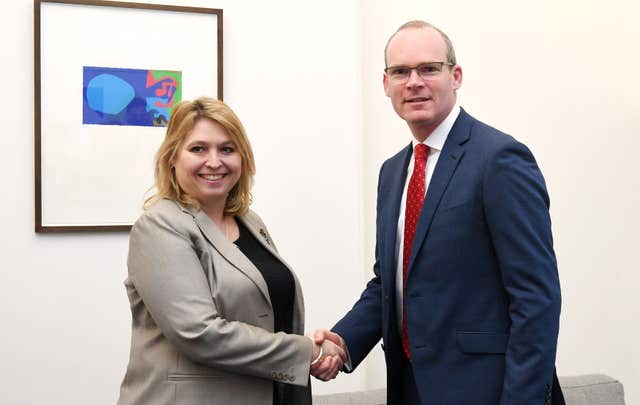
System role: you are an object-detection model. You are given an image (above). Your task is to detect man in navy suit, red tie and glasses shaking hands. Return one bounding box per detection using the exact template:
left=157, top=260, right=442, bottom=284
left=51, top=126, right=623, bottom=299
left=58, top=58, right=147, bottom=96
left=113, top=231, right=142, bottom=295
left=313, top=21, right=564, bottom=405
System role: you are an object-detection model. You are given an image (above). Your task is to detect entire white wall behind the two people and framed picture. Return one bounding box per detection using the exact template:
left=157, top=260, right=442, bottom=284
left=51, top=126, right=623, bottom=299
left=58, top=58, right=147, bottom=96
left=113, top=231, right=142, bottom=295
left=0, top=0, right=640, bottom=405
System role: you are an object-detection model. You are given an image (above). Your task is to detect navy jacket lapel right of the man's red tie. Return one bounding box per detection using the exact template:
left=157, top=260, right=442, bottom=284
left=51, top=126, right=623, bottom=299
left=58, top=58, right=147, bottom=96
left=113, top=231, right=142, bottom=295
left=407, top=109, right=472, bottom=272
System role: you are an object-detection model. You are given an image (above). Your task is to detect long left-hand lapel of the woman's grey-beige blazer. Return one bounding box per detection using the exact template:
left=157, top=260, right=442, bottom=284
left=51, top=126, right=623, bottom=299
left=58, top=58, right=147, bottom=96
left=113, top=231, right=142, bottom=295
left=188, top=208, right=271, bottom=305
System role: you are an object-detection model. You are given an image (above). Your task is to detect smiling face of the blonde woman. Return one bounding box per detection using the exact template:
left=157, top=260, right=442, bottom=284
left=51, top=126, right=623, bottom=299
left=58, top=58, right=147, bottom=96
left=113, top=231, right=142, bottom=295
left=174, top=118, right=242, bottom=212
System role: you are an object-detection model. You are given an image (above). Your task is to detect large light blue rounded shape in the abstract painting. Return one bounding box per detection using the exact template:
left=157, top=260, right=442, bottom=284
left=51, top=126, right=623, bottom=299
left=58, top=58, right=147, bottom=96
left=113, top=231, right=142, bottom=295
left=85, top=74, right=136, bottom=115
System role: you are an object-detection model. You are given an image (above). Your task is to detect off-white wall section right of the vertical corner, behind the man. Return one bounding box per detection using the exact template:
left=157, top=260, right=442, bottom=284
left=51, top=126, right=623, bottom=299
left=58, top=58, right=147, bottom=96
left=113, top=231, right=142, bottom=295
left=363, top=0, right=640, bottom=404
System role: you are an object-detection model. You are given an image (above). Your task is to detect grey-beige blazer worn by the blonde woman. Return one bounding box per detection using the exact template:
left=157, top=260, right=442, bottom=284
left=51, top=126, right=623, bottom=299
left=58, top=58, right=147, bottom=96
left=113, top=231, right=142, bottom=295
left=118, top=200, right=312, bottom=405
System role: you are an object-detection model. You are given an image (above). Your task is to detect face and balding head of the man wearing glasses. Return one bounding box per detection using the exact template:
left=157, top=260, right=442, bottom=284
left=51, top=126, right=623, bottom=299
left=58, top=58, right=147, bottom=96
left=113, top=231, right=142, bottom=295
left=383, top=28, right=462, bottom=141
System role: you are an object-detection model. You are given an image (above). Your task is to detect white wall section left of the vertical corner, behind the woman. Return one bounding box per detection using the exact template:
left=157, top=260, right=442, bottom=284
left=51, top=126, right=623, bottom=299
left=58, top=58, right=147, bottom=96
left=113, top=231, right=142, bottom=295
left=0, top=0, right=365, bottom=405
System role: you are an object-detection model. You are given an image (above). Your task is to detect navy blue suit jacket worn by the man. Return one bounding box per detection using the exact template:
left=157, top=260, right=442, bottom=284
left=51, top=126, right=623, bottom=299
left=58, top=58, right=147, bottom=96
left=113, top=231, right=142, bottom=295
left=333, top=110, right=564, bottom=405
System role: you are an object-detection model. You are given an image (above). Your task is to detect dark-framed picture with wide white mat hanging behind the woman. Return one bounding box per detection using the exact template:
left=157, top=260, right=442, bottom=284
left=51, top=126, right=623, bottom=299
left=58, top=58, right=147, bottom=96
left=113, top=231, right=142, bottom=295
left=34, top=0, right=222, bottom=232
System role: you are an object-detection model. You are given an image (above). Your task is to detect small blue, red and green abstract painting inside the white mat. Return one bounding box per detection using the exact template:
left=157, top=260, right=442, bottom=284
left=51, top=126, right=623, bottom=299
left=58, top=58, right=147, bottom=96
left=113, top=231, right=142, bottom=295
left=82, top=66, right=182, bottom=127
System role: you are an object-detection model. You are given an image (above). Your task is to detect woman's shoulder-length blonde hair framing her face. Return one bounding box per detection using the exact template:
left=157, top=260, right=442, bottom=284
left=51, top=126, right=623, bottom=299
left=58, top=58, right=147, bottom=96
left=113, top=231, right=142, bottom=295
left=144, top=97, right=256, bottom=215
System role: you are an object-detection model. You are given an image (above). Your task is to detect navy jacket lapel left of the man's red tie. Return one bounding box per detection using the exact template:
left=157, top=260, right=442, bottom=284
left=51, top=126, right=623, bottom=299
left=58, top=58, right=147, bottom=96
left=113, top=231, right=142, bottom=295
left=378, top=144, right=412, bottom=291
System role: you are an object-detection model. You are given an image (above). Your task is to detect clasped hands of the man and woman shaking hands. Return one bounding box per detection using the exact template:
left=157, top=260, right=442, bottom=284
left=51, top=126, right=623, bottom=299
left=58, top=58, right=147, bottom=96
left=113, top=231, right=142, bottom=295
left=310, top=329, right=349, bottom=381
